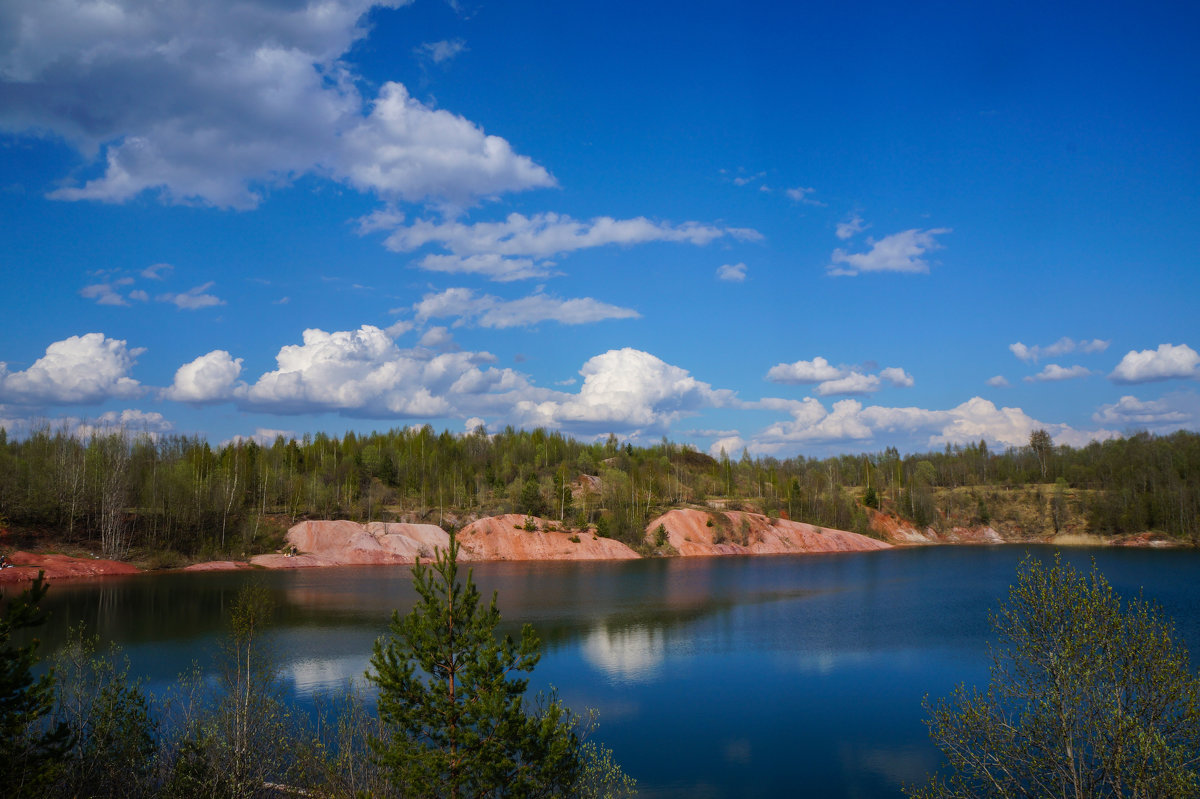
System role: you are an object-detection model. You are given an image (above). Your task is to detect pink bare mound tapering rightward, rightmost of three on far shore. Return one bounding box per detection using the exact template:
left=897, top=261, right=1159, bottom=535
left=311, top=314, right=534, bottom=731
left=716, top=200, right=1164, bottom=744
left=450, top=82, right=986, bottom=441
left=646, top=510, right=892, bottom=557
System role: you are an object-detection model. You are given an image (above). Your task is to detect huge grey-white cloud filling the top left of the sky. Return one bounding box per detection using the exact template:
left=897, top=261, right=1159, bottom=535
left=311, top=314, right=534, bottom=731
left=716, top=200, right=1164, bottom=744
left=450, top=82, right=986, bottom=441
left=0, top=0, right=554, bottom=209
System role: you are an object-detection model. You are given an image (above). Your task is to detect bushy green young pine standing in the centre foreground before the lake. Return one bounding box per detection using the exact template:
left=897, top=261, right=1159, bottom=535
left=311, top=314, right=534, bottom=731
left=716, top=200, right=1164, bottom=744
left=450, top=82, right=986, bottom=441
left=367, top=525, right=581, bottom=798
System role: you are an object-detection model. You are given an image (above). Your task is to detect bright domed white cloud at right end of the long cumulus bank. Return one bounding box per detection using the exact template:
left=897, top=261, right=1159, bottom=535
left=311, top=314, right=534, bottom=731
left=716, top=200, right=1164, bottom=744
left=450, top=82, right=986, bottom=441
left=516, top=347, right=734, bottom=433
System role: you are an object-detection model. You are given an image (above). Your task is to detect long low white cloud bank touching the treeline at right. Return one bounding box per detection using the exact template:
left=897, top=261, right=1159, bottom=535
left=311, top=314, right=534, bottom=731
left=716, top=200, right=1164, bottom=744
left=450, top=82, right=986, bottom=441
left=750, top=397, right=1116, bottom=453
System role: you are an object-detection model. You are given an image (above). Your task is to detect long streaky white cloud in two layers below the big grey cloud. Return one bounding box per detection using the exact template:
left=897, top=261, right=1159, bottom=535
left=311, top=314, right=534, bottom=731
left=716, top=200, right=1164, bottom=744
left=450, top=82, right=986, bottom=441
left=374, top=214, right=762, bottom=281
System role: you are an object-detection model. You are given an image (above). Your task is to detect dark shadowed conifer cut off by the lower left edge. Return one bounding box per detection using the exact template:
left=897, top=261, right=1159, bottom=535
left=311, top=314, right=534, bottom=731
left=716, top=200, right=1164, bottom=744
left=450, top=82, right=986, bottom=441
left=0, top=572, right=71, bottom=799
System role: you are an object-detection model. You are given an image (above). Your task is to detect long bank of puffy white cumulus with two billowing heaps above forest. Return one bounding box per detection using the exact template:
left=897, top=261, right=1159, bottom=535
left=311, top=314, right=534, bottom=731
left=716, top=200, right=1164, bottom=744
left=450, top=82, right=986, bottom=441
left=228, top=325, right=736, bottom=434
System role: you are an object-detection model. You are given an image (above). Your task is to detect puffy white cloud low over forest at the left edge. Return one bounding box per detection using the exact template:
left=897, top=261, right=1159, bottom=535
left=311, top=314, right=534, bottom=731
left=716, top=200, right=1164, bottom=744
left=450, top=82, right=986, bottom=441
left=0, top=332, right=145, bottom=405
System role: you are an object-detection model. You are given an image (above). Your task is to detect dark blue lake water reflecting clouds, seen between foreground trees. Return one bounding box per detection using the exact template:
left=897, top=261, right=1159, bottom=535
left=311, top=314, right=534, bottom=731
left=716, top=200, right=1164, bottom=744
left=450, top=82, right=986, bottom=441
left=9, top=546, right=1200, bottom=799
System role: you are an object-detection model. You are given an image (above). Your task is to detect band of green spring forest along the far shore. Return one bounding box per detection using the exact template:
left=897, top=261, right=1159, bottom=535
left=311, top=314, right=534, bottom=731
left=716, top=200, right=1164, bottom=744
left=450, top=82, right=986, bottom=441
left=0, top=426, right=1200, bottom=556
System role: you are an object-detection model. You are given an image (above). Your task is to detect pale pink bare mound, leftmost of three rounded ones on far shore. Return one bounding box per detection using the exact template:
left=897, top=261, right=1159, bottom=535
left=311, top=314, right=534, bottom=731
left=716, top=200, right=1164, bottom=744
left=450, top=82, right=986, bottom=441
left=251, top=521, right=450, bottom=569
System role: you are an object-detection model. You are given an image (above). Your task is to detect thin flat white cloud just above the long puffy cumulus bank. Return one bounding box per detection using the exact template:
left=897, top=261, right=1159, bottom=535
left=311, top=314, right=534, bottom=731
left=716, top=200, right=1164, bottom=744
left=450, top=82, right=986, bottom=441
left=413, top=288, right=641, bottom=329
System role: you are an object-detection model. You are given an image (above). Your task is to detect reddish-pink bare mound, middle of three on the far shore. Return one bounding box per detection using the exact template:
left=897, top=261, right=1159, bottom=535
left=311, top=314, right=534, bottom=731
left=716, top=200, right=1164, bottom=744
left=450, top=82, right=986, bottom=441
left=458, top=513, right=638, bottom=560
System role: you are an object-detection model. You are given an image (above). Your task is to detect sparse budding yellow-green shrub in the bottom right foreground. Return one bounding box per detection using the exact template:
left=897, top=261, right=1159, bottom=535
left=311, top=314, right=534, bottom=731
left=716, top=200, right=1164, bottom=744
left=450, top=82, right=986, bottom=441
left=908, top=557, right=1200, bottom=799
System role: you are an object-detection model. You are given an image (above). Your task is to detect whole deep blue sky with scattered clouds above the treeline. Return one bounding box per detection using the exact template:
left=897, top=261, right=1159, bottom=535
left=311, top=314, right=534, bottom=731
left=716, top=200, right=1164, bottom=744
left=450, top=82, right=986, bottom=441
left=0, top=0, right=1200, bottom=457
